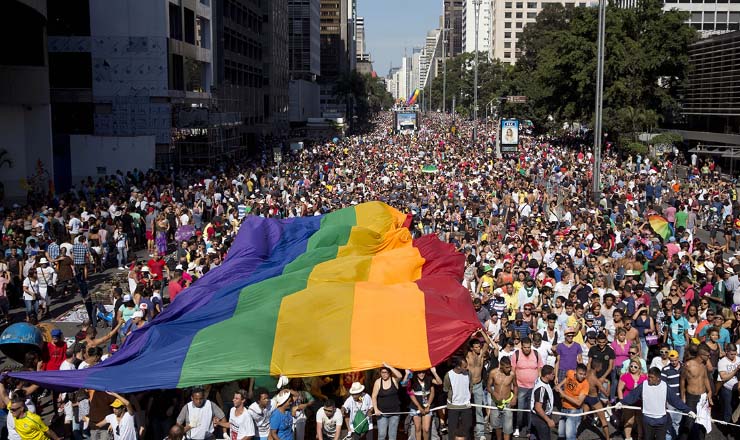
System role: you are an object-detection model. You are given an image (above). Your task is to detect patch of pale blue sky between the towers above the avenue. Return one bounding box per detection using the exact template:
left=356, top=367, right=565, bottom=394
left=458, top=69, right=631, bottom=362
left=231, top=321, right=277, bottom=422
left=357, top=0, right=442, bottom=76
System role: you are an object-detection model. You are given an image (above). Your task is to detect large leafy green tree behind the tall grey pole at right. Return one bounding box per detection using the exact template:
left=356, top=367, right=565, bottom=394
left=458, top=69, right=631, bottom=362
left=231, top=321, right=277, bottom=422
left=510, top=0, right=696, bottom=133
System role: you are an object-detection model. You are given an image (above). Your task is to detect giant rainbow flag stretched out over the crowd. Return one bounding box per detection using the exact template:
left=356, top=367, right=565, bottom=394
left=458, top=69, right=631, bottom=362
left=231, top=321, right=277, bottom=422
left=11, top=202, right=480, bottom=392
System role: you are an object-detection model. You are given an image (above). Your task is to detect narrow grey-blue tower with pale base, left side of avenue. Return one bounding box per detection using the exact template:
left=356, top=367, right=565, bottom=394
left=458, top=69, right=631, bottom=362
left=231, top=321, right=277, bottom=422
left=288, top=0, right=321, bottom=123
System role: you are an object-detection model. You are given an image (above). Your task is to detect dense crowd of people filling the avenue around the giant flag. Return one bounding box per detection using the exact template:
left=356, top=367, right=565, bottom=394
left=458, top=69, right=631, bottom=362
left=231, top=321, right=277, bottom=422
left=0, top=110, right=740, bottom=440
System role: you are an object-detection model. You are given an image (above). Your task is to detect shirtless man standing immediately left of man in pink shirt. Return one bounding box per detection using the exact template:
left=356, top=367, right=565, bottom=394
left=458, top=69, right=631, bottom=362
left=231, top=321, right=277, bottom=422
left=488, top=357, right=516, bottom=440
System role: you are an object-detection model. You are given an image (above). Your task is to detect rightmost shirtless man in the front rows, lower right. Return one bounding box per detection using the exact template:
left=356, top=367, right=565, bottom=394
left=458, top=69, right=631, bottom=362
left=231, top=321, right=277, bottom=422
left=679, top=344, right=713, bottom=440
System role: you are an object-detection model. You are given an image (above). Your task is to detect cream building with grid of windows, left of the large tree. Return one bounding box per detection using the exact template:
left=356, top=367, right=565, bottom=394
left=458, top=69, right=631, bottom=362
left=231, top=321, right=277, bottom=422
left=489, top=0, right=598, bottom=64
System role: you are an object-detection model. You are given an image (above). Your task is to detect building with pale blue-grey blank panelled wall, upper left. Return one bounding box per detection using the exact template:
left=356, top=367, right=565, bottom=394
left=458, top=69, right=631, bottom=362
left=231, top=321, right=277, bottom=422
left=48, top=0, right=249, bottom=186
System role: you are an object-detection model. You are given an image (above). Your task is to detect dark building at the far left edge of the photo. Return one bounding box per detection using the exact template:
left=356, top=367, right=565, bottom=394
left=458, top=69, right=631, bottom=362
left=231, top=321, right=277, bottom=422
left=0, top=0, right=53, bottom=206
